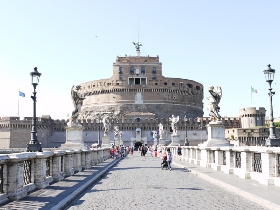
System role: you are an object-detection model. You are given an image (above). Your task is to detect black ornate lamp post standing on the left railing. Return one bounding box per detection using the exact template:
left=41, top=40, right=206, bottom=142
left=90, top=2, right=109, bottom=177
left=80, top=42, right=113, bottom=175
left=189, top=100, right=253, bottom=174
left=26, top=67, right=42, bottom=152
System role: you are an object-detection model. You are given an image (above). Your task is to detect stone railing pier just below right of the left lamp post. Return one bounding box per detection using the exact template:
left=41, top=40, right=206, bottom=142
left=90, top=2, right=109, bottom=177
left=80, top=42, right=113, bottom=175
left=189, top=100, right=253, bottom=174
left=34, top=151, right=54, bottom=189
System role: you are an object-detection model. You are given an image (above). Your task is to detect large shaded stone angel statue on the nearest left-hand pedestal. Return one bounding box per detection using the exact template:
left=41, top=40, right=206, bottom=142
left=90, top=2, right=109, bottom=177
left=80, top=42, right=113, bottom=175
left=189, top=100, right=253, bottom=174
left=70, top=85, right=86, bottom=123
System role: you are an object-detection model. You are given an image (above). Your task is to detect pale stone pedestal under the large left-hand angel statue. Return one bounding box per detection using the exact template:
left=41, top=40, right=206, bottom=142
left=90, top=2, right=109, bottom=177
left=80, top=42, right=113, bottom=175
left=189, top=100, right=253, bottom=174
left=60, top=123, right=87, bottom=150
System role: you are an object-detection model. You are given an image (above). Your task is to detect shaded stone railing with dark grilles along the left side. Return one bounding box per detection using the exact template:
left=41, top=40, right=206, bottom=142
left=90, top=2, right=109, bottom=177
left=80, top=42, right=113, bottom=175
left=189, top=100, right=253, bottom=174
left=0, top=148, right=110, bottom=204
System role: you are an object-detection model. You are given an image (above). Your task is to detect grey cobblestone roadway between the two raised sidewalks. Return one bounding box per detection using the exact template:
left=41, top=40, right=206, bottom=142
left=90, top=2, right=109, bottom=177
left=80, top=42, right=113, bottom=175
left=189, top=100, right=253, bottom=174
left=66, top=152, right=265, bottom=210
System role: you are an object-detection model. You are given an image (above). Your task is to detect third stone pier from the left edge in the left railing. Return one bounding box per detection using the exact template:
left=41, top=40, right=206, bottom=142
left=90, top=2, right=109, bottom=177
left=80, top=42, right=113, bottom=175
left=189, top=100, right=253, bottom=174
left=52, top=150, right=66, bottom=181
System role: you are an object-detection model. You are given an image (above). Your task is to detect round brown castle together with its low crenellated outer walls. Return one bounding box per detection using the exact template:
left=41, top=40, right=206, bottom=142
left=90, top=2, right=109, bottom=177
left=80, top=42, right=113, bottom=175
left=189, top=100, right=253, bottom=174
left=0, top=43, right=240, bottom=149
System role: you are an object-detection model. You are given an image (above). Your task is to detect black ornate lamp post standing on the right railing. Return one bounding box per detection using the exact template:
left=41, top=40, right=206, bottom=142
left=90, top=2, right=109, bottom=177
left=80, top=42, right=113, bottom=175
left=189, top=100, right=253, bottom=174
left=263, top=64, right=280, bottom=146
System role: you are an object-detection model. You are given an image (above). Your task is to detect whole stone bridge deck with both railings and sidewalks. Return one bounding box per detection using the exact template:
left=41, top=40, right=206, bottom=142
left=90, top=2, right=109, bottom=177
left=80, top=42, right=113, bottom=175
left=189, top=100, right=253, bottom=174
left=0, top=146, right=280, bottom=209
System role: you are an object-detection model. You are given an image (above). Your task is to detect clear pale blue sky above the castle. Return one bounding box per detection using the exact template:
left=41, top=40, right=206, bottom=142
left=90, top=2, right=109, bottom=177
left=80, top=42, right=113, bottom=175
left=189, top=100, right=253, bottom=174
left=0, top=0, right=280, bottom=119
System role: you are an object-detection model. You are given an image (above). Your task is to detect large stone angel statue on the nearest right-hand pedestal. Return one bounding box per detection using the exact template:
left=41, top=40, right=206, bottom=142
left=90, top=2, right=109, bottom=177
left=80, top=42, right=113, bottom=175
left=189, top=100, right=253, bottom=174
left=207, top=86, right=222, bottom=122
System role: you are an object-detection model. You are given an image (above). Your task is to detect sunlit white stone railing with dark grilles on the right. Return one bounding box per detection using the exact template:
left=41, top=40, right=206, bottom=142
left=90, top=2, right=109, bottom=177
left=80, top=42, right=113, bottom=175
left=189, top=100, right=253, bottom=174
left=167, top=146, right=280, bottom=186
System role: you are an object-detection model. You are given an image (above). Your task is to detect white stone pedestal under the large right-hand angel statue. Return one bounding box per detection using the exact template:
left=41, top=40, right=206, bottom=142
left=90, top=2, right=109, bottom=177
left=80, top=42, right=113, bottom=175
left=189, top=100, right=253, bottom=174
left=198, top=121, right=233, bottom=147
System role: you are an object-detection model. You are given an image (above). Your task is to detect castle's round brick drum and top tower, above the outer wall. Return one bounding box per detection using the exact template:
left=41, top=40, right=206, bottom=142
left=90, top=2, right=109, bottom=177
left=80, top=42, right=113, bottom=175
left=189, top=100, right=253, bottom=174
left=79, top=43, right=203, bottom=119
